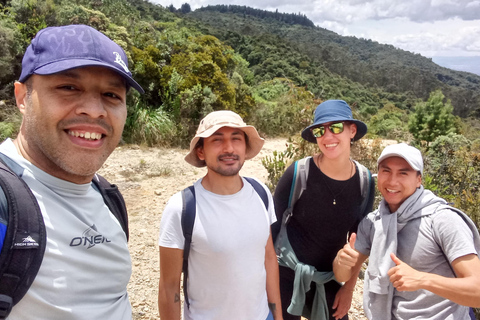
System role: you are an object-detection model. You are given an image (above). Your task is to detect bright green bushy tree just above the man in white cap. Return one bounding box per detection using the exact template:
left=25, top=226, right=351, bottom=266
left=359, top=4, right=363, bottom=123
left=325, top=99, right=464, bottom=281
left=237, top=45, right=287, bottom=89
left=408, top=90, right=457, bottom=144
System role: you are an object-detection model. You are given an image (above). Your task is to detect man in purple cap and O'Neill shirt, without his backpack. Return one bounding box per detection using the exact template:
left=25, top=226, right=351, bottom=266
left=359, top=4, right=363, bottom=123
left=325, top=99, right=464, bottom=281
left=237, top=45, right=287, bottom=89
left=0, top=25, right=143, bottom=320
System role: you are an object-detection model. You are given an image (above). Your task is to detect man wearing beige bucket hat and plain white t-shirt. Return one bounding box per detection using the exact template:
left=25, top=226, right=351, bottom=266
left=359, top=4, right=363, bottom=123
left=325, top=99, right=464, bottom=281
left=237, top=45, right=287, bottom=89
left=158, top=110, right=283, bottom=320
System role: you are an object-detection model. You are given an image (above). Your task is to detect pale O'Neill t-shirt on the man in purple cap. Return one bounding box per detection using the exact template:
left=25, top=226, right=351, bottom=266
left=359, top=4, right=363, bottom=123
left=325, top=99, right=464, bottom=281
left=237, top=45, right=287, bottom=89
left=0, top=140, right=132, bottom=320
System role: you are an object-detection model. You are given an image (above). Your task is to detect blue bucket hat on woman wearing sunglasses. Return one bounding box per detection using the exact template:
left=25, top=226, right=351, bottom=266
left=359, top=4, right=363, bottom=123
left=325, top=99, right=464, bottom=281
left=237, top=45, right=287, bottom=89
left=302, top=100, right=367, bottom=143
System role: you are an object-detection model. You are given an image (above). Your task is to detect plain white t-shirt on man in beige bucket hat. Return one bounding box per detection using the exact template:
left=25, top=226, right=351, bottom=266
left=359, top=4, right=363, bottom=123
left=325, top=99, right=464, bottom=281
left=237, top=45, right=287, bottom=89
left=159, top=179, right=276, bottom=320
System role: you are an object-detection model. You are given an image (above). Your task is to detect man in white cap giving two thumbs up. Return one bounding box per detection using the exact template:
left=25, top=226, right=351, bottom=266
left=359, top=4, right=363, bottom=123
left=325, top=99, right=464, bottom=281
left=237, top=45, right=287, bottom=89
left=333, top=143, right=480, bottom=320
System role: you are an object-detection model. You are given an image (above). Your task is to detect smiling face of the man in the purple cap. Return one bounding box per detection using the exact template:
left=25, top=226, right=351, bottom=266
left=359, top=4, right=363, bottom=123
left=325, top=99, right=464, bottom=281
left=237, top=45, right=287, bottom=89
left=15, top=67, right=127, bottom=183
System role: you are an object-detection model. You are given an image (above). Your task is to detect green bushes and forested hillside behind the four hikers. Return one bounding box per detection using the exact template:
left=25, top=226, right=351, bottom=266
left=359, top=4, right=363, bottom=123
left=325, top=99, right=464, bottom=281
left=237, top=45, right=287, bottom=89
left=0, top=0, right=480, bottom=258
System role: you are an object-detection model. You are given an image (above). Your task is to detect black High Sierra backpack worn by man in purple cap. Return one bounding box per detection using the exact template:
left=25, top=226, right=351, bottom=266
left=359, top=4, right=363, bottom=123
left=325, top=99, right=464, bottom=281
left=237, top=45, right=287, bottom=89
left=0, top=153, right=128, bottom=319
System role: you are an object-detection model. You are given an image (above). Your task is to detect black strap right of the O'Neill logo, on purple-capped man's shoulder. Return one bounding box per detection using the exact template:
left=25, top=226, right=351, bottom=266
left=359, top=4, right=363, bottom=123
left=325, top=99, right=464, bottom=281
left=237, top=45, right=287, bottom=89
left=92, top=174, right=129, bottom=241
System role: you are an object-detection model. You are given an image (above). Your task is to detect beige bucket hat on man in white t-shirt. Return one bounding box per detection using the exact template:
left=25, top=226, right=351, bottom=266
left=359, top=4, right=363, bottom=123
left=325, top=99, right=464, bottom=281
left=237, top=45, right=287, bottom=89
left=185, top=110, right=265, bottom=168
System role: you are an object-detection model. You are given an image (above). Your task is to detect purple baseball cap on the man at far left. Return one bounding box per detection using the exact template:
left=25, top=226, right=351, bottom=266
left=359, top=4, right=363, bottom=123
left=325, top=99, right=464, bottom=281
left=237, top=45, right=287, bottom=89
left=18, top=25, right=145, bottom=93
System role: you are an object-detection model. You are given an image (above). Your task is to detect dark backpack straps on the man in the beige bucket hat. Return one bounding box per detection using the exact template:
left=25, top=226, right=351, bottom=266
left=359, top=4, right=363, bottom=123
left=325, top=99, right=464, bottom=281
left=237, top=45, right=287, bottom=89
left=181, top=177, right=268, bottom=308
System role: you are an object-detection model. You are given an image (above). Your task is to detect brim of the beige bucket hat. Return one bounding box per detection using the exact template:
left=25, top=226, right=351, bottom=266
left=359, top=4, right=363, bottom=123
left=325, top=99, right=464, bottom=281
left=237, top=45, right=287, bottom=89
left=185, top=124, right=265, bottom=168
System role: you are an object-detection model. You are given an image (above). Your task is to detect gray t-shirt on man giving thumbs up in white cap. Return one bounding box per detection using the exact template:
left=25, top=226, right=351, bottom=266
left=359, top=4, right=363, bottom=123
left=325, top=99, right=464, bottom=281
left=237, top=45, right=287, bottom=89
left=355, top=210, right=476, bottom=320
